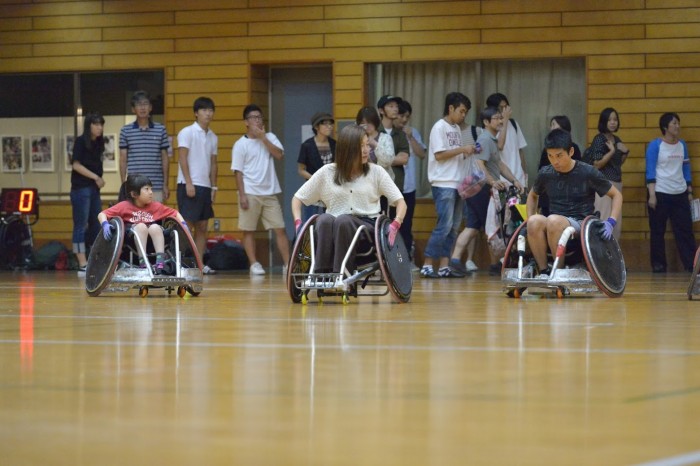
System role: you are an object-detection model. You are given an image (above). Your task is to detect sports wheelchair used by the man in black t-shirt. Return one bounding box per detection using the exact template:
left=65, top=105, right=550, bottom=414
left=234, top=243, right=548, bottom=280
left=501, top=216, right=627, bottom=298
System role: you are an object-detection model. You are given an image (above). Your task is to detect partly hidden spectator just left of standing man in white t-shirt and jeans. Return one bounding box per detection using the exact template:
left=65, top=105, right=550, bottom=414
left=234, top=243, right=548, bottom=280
left=394, top=100, right=426, bottom=260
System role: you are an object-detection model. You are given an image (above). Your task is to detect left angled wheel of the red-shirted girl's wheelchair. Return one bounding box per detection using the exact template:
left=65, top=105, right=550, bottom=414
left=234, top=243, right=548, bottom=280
left=85, top=217, right=124, bottom=296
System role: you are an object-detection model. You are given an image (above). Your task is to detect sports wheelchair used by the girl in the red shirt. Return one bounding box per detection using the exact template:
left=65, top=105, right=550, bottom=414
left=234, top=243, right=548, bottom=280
left=85, top=217, right=203, bottom=298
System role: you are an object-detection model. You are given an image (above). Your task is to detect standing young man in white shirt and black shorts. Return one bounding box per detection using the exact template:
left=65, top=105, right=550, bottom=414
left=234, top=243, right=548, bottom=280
left=177, top=97, right=219, bottom=274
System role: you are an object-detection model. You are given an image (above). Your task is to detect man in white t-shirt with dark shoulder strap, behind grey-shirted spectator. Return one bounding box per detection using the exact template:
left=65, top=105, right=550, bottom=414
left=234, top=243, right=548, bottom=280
left=486, top=92, right=527, bottom=186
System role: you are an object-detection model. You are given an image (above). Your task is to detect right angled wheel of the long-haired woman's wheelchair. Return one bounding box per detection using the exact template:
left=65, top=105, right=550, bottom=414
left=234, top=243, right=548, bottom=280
left=374, top=215, right=413, bottom=303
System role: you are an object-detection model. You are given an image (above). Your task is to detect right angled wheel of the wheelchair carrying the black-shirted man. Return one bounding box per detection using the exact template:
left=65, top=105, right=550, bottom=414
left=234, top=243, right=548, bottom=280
left=581, top=216, right=627, bottom=298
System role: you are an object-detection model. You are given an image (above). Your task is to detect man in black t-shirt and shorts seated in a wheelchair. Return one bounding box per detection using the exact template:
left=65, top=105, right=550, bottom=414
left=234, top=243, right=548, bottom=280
left=527, top=129, right=622, bottom=275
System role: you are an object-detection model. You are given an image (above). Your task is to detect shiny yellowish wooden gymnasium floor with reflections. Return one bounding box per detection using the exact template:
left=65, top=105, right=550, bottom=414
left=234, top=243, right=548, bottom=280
left=0, top=272, right=700, bottom=466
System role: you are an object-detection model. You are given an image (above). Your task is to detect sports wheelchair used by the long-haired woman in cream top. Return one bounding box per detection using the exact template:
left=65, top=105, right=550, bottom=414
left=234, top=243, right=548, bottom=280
left=287, top=215, right=413, bottom=304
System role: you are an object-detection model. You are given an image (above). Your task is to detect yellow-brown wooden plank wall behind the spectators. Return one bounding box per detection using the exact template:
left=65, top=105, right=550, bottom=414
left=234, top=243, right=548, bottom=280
left=0, top=0, right=700, bottom=268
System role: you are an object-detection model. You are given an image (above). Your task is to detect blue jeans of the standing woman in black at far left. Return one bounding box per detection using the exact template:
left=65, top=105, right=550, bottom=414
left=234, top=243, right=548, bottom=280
left=70, top=185, right=102, bottom=253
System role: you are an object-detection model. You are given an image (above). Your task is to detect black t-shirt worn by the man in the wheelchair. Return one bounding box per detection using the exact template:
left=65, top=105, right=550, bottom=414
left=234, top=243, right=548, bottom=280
left=532, top=162, right=612, bottom=220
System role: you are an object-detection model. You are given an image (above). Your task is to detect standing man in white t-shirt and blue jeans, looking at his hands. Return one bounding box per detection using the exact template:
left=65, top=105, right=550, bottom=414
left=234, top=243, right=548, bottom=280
left=420, top=92, right=475, bottom=278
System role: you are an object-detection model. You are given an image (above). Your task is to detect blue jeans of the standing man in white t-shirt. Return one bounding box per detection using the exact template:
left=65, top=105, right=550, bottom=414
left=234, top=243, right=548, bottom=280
left=425, top=186, right=464, bottom=259
